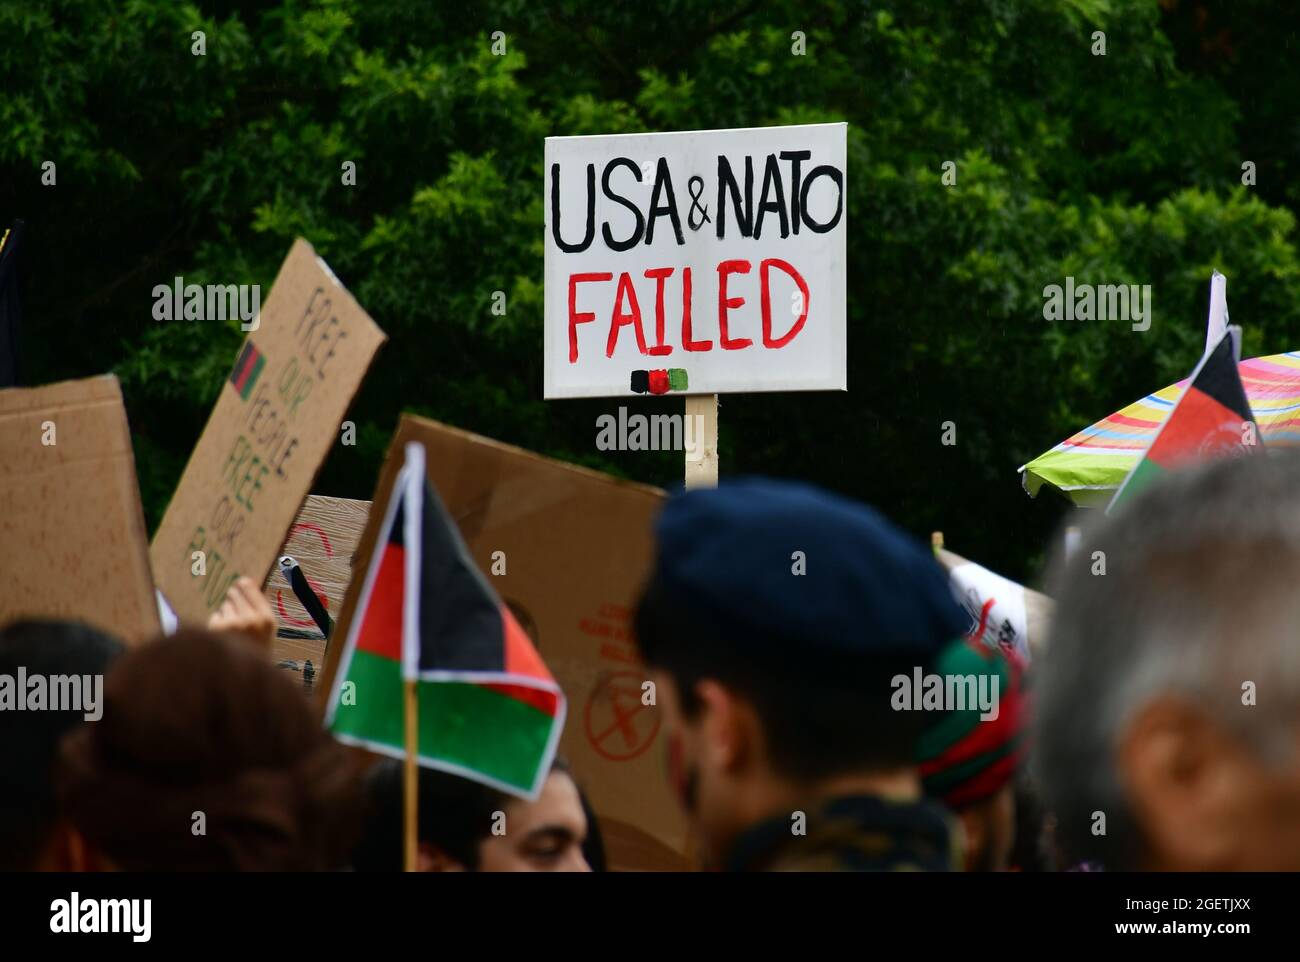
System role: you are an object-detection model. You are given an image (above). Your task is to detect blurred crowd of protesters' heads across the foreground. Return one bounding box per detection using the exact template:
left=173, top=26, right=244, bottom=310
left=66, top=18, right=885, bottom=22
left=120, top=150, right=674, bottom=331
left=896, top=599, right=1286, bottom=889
left=0, top=454, right=1300, bottom=871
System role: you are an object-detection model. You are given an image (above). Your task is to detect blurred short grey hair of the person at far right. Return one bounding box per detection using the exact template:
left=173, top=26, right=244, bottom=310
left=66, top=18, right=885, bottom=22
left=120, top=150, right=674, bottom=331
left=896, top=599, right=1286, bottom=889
left=1032, top=451, right=1300, bottom=868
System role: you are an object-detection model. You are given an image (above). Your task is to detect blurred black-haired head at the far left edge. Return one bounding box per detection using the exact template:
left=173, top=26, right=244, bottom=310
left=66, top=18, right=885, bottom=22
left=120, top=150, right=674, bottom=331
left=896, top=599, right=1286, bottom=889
left=0, top=620, right=122, bottom=871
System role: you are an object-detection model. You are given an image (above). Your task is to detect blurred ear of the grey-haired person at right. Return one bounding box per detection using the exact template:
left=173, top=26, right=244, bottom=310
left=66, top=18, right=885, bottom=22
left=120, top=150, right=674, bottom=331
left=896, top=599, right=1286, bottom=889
left=1117, top=697, right=1248, bottom=871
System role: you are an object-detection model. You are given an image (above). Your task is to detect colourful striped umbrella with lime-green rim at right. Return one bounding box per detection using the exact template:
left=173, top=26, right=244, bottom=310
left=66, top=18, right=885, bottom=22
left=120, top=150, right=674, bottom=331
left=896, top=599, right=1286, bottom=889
left=1021, top=351, right=1300, bottom=506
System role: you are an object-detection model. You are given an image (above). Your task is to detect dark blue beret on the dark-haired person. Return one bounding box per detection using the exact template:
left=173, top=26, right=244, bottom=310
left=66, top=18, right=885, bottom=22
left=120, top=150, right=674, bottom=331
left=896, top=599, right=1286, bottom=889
left=654, top=478, right=970, bottom=658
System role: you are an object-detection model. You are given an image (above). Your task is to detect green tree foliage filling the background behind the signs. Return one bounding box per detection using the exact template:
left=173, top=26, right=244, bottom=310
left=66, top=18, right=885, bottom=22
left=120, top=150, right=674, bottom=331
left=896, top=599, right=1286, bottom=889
left=0, top=0, right=1300, bottom=577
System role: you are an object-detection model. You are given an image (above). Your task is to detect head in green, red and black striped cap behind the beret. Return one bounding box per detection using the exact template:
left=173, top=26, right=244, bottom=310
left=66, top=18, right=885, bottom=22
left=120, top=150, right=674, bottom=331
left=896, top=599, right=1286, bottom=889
left=917, top=638, right=1027, bottom=871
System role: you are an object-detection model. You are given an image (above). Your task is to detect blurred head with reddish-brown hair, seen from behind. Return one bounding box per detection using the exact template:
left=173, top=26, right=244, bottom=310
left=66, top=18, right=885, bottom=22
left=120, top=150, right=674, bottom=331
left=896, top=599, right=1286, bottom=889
left=56, top=629, right=360, bottom=871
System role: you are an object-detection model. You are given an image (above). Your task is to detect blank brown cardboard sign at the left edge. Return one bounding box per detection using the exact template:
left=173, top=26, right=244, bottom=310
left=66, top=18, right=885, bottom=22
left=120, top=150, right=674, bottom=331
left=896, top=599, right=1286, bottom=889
left=0, top=376, right=159, bottom=644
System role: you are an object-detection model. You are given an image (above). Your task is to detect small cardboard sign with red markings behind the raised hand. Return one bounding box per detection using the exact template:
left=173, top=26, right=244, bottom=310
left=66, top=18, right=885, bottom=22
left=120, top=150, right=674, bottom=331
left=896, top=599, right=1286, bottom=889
left=263, top=494, right=371, bottom=668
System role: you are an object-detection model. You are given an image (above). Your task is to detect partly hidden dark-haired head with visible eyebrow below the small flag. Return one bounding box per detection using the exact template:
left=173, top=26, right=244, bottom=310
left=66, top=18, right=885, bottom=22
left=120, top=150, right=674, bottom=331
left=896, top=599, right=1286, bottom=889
left=352, top=759, right=595, bottom=872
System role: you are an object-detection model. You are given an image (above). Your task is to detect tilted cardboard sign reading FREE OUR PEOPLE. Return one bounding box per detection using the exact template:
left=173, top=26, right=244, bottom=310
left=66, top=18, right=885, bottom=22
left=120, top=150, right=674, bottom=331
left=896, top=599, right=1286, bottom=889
left=150, top=239, right=386, bottom=621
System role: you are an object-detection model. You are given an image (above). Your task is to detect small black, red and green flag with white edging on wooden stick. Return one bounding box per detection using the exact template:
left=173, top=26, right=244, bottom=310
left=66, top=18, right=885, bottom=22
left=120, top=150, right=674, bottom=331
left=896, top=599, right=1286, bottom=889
left=325, top=443, right=564, bottom=798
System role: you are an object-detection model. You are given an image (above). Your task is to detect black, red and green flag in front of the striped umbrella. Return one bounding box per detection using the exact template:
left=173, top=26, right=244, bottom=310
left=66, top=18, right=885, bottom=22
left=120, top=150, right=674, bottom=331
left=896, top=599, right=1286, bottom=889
left=1106, top=328, right=1260, bottom=514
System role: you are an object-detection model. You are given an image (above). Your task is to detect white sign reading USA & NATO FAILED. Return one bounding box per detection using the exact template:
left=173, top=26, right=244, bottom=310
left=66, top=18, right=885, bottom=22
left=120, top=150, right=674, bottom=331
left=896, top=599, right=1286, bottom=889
left=545, top=124, right=848, bottom=398
